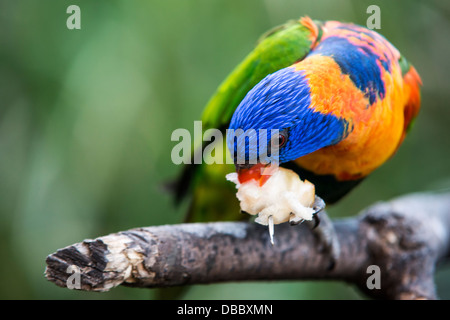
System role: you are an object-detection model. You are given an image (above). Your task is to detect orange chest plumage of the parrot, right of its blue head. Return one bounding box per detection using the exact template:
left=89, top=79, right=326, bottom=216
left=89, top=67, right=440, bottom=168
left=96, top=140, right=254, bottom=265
left=295, top=55, right=406, bottom=180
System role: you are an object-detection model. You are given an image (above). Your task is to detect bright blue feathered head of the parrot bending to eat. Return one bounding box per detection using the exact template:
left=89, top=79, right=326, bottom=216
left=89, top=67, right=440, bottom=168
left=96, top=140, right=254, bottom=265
left=227, top=67, right=348, bottom=182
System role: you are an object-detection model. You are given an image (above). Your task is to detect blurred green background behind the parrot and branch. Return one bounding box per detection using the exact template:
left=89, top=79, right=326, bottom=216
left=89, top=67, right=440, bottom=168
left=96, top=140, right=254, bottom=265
left=0, top=0, right=450, bottom=299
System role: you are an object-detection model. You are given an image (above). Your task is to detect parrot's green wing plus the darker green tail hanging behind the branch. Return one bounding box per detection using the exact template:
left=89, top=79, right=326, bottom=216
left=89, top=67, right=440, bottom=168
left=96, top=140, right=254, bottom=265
left=175, top=18, right=319, bottom=221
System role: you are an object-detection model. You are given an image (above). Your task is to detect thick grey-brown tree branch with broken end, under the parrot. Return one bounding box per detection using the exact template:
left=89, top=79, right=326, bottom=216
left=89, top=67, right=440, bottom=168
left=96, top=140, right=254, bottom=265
left=45, top=194, right=450, bottom=299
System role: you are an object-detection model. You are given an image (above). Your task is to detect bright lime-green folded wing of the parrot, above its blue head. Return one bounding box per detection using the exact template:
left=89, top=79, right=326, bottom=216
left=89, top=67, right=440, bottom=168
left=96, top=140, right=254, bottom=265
left=202, top=18, right=316, bottom=129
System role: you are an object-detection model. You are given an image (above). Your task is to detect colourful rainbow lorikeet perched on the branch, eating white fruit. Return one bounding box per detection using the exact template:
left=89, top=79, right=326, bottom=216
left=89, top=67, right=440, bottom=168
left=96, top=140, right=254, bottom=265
left=176, top=17, right=421, bottom=226
